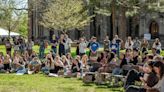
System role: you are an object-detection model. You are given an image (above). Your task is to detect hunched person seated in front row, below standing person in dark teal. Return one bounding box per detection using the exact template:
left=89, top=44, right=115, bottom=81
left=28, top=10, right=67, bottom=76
left=28, top=57, right=41, bottom=74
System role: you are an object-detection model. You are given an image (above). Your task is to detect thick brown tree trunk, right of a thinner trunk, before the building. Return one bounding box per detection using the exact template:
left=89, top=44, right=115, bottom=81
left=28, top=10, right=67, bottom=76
left=118, top=7, right=127, bottom=41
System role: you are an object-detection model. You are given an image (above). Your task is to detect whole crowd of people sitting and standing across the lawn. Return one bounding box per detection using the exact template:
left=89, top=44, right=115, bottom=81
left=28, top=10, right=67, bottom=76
left=0, top=34, right=164, bottom=92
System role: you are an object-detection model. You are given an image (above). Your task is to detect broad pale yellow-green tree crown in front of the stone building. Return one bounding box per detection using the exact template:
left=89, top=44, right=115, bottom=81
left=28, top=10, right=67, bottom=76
left=40, top=0, right=92, bottom=33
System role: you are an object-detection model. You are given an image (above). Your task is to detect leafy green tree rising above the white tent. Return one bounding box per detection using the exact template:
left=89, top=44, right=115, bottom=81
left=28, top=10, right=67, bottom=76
left=0, top=0, right=24, bottom=36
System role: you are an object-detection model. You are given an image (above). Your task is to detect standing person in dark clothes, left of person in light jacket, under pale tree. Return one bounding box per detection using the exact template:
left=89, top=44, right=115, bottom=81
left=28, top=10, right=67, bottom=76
left=59, top=34, right=66, bottom=56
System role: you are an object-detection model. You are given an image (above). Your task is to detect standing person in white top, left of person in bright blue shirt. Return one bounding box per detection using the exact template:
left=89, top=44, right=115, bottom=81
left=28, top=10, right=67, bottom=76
left=79, top=38, right=87, bottom=56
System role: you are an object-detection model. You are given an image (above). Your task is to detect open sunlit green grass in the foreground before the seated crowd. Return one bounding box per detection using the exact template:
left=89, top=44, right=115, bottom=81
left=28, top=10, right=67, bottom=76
left=0, top=74, right=124, bottom=92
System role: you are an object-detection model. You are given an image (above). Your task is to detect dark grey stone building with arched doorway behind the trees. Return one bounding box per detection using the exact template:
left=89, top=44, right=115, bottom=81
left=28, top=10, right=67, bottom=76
left=29, top=0, right=164, bottom=42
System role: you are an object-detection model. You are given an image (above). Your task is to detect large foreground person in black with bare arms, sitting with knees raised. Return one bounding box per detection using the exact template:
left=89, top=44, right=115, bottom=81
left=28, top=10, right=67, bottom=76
left=125, top=61, right=158, bottom=92
